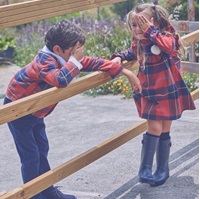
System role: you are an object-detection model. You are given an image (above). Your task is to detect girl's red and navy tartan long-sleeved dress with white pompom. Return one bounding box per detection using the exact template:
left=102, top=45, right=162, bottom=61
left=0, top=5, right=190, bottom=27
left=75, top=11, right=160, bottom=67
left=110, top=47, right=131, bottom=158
left=112, top=26, right=195, bottom=120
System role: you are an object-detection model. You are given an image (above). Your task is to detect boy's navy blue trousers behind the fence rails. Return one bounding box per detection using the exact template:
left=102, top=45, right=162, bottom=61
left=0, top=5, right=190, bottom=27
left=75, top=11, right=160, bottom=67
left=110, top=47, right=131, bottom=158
left=4, top=98, right=52, bottom=197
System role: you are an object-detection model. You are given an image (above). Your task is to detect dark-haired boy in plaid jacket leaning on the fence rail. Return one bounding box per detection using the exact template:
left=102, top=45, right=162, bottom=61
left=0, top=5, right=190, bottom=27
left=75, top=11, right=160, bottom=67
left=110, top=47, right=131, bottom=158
left=4, top=20, right=141, bottom=199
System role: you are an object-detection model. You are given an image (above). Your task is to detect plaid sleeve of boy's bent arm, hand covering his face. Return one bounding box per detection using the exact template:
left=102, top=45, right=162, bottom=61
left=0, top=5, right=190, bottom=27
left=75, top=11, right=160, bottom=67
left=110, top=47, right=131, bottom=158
left=36, top=57, right=80, bottom=88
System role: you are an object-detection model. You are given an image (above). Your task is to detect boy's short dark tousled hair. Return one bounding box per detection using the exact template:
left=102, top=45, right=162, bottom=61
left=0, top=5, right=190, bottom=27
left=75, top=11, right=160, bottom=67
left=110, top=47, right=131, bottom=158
left=44, top=20, right=85, bottom=52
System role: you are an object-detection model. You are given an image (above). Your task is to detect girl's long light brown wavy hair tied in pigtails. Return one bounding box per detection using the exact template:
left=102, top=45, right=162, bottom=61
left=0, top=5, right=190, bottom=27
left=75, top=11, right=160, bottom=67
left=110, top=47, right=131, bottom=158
left=127, top=3, right=184, bottom=61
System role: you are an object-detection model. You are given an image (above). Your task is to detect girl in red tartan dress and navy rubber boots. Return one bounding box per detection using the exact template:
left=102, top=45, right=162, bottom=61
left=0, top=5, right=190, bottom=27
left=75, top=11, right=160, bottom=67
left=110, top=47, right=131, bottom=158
left=111, top=3, right=195, bottom=186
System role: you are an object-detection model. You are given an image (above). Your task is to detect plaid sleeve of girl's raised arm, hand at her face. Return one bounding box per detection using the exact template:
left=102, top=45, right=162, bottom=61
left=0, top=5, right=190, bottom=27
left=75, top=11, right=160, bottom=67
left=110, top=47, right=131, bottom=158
left=144, top=26, right=178, bottom=54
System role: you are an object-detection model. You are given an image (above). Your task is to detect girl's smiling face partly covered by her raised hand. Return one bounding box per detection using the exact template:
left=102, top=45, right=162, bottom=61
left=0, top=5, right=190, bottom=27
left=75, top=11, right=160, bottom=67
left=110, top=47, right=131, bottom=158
left=131, top=12, right=150, bottom=40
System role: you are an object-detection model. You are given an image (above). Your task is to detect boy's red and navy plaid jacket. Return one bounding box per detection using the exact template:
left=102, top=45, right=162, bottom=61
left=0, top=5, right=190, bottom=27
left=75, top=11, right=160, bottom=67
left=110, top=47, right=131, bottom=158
left=6, top=50, right=123, bottom=118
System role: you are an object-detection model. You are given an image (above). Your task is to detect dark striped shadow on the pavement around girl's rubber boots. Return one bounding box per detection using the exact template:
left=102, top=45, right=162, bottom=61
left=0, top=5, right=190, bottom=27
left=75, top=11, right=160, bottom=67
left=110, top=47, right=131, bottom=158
left=104, top=139, right=199, bottom=199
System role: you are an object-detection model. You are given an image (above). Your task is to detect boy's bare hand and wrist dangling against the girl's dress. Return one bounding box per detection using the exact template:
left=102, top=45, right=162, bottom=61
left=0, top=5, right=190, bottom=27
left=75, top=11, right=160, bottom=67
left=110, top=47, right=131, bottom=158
left=121, top=68, right=142, bottom=93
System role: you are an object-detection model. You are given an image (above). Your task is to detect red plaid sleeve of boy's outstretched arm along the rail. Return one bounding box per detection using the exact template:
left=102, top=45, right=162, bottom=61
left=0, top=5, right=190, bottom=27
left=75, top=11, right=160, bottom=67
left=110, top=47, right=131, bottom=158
left=81, top=56, right=123, bottom=78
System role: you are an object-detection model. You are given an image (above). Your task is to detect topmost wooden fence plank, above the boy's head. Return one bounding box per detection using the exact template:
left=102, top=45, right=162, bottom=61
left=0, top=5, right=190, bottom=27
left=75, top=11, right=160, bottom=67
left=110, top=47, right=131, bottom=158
left=0, top=0, right=125, bottom=29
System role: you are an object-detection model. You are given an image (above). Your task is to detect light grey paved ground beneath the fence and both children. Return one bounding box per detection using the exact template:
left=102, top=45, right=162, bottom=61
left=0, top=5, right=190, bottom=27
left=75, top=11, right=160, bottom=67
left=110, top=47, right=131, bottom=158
left=0, top=92, right=199, bottom=199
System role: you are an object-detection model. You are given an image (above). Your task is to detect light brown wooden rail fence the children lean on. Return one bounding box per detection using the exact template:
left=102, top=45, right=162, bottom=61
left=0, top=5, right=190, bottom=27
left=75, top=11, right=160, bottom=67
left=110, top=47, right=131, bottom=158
left=0, top=0, right=199, bottom=199
